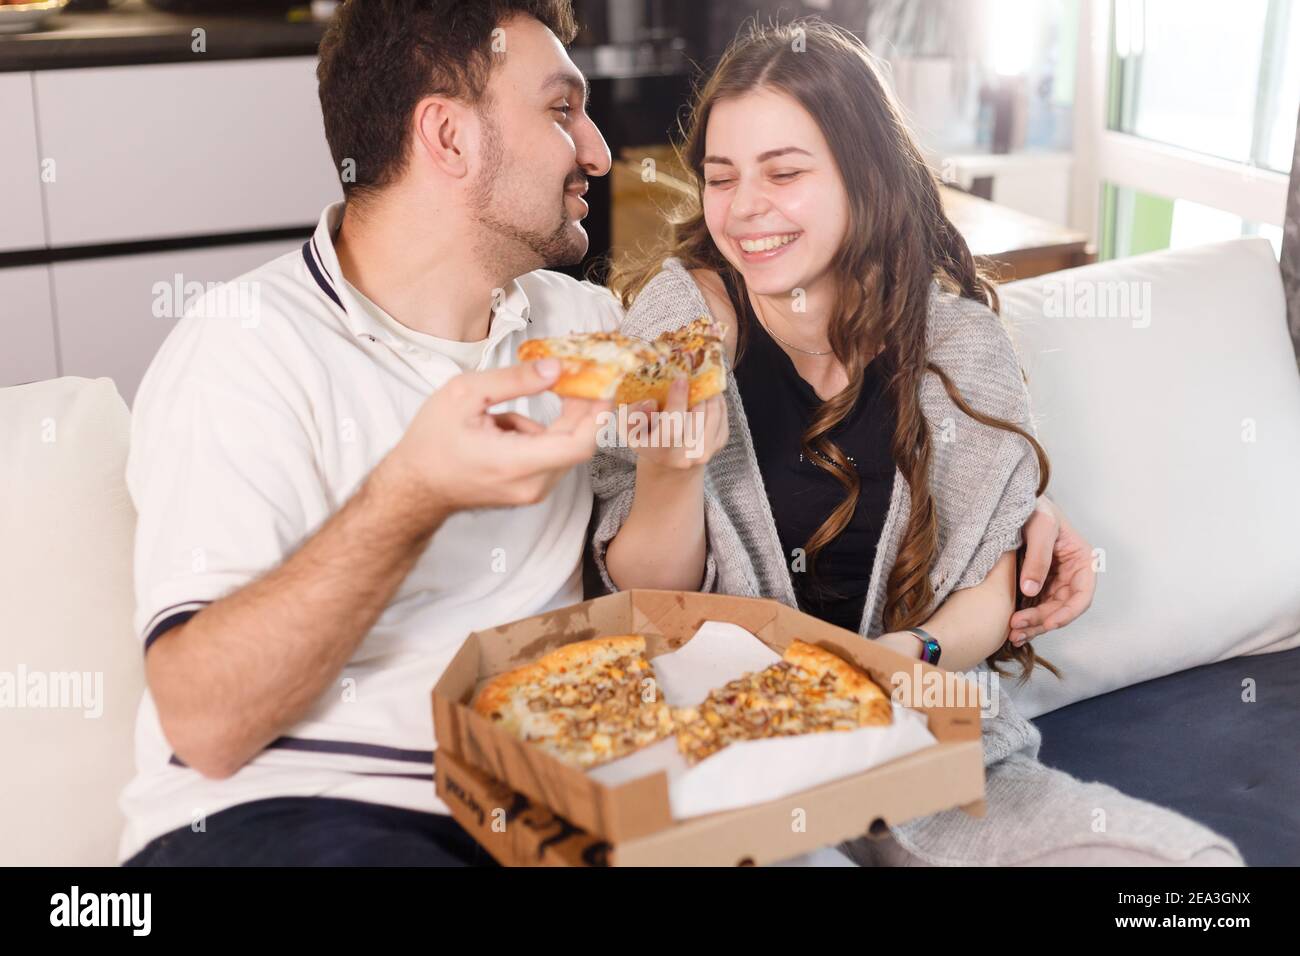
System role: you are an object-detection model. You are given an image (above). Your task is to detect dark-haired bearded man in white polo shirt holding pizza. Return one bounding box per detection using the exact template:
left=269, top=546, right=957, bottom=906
left=120, top=0, right=1091, bottom=865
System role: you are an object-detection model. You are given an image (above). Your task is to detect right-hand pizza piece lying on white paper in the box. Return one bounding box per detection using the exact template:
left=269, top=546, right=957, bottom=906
left=673, top=640, right=893, bottom=765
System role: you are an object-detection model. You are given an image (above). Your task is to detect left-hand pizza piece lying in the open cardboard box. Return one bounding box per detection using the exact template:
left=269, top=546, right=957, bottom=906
left=473, top=635, right=672, bottom=769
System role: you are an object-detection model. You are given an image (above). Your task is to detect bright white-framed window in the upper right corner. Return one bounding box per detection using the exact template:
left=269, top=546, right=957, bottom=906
left=1093, top=0, right=1300, bottom=258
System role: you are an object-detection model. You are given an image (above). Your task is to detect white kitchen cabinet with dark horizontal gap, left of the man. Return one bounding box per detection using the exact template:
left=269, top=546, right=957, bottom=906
left=0, top=56, right=342, bottom=402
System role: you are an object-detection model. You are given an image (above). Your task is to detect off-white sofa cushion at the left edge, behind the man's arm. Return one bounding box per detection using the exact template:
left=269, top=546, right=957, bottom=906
left=0, top=378, right=144, bottom=866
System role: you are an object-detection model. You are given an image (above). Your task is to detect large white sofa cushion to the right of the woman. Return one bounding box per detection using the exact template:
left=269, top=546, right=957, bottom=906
left=1002, top=239, right=1300, bottom=717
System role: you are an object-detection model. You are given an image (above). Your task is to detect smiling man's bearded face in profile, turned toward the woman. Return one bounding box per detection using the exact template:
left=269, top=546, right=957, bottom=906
left=469, top=17, right=610, bottom=274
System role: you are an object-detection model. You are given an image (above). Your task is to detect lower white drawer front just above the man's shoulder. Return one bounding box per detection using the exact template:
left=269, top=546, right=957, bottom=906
left=51, top=239, right=302, bottom=405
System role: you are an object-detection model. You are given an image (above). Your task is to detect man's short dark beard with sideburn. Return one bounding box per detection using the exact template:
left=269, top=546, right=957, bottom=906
left=471, top=113, right=586, bottom=276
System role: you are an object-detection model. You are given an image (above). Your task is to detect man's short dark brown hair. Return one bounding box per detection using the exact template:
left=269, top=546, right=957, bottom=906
left=316, top=0, right=577, bottom=199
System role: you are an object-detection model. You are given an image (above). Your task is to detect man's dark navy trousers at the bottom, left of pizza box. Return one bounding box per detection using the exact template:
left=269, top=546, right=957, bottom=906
left=122, top=797, right=495, bottom=866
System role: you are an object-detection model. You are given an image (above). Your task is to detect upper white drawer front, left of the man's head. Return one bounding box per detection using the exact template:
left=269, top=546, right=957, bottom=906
left=35, top=57, right=342, bottom=247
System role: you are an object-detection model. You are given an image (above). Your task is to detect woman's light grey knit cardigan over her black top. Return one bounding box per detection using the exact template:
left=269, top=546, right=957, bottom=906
left=592, top=259, right=1240, bottom=865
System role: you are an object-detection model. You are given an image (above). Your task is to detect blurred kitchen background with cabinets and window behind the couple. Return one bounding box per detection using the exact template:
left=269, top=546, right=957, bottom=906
left=0, top=0, right=1300, bottom=402
